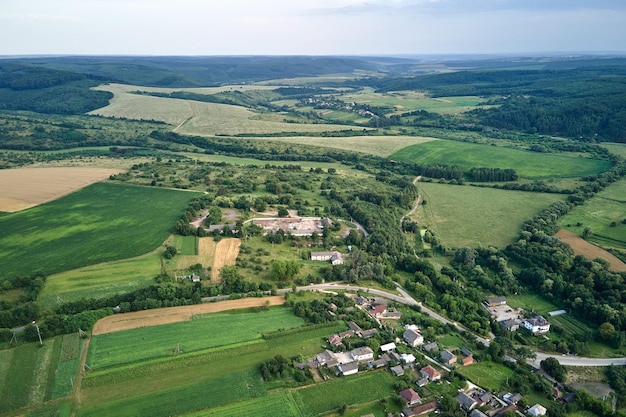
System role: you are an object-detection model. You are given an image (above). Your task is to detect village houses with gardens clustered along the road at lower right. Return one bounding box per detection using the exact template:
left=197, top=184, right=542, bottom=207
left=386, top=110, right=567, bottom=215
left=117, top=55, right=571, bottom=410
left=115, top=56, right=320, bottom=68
left=298, top=295, right=560, bottom=417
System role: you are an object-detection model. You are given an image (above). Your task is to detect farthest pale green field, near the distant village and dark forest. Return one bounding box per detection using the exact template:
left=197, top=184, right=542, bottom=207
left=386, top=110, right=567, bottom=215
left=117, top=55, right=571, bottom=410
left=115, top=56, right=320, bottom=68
left=339, top=89, right=485, bottom=114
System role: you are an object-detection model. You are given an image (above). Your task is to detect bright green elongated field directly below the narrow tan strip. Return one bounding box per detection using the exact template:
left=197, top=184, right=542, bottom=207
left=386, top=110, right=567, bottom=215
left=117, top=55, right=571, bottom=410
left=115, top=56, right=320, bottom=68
left=87, top=307, right=303, bottom=369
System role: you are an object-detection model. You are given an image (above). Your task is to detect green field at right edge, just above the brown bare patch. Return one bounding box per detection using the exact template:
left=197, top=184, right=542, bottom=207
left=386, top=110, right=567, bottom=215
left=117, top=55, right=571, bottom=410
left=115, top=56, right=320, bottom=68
left=559, top=178, right=626, bottom=249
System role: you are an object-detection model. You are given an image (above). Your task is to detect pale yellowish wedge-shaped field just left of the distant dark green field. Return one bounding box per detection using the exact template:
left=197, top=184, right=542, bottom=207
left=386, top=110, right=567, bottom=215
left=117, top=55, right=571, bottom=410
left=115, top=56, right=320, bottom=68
left=248, top=136, right=437, bottom=157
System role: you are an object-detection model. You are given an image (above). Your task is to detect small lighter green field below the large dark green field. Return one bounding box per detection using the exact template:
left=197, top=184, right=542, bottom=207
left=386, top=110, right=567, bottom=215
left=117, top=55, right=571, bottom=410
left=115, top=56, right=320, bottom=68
left=37, top=250, right=161, bottom=310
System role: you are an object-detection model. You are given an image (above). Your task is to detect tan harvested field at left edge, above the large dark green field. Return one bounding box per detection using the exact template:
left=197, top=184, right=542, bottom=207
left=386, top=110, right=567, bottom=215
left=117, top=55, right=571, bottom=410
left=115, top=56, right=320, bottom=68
left=0, top=167, right=122, bottom=212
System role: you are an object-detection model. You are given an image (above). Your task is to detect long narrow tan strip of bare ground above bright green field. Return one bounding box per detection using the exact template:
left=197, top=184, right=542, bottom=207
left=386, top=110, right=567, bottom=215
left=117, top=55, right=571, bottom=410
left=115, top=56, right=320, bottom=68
left=92, top=295, right=285, bottom=336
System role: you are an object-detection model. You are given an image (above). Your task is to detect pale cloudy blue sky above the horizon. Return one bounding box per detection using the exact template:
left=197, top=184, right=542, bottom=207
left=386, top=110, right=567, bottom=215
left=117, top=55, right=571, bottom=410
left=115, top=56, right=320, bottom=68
left=0, top=0, right=626, bottom=55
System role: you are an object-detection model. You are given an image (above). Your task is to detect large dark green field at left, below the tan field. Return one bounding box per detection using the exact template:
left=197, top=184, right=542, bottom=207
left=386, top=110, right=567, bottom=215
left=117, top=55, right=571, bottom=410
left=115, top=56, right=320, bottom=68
left=0, top=183, right=195, bottom=280
